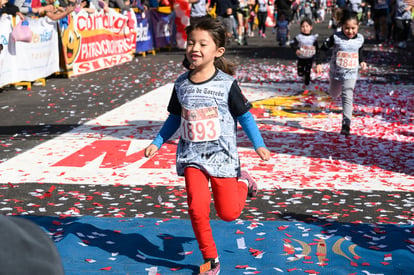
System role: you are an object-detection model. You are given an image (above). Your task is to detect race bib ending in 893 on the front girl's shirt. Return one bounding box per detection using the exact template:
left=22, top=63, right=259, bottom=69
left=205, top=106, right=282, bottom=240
left=181, top=107, right=220, bottom=142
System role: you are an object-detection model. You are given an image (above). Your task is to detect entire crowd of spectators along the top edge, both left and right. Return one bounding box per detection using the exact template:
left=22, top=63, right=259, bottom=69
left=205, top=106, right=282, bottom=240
left=0, top=0, right=414, bottom=48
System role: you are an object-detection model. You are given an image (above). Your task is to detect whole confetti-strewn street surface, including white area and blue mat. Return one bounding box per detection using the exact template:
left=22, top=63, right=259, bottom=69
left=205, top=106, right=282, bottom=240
left=0, top=20, right=414, bottom=275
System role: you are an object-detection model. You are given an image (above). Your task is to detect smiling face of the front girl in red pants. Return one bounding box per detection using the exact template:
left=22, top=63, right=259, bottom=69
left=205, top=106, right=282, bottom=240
left=186, top=29, right=225, bottom=69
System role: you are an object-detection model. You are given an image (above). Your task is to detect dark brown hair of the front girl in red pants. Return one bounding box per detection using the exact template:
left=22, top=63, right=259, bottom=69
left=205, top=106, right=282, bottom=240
left=185, top=17, right=236, bottom=75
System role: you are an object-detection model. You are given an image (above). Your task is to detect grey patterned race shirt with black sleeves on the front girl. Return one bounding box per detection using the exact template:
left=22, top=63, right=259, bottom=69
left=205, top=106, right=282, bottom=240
left=168, top=70, right=251, bottom=177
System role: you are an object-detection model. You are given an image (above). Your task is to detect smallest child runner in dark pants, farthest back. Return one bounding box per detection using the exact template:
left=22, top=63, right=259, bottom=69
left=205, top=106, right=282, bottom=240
left=291, top=17, right=319, bottom=85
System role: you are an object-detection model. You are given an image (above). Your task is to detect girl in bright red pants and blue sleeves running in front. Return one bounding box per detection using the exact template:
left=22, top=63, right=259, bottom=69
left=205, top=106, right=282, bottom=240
left=145, top=18, right=270, bottom=274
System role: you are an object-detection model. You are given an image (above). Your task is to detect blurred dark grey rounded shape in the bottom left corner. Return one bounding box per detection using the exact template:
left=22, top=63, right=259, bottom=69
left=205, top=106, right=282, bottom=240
left=0, top=216, right=64, bottom=275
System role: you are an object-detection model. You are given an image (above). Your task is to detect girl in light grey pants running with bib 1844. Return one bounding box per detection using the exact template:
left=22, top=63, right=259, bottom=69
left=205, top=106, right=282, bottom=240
left=316, top=10, right=367, bottom=136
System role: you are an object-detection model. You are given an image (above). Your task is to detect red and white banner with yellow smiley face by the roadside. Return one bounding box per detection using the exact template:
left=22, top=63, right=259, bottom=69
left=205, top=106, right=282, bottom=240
left=60, top=10, right=136, bottom=76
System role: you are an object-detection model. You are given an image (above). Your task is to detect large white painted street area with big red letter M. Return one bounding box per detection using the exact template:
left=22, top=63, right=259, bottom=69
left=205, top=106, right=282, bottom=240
left=0, top=84, right=414, bottom=191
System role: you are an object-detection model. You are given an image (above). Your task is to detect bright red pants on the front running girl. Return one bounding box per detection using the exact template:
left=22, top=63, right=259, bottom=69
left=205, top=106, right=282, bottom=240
left=184, top=167, right=248, bottom=259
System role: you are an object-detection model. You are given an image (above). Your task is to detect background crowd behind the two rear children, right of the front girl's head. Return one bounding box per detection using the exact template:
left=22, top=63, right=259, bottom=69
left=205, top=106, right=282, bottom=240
left=186, top=0, right=414, bottom=48
